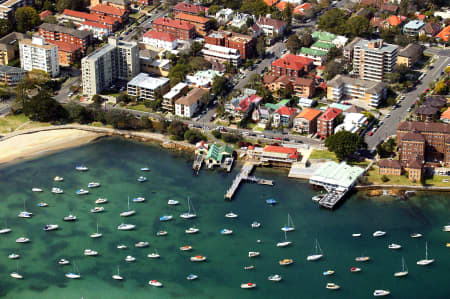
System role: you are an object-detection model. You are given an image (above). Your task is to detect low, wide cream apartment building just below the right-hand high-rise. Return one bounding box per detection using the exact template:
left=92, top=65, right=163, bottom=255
left=327, top=75, right=387, bottom=107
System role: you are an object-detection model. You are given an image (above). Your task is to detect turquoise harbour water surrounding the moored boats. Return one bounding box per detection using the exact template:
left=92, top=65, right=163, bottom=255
left=0, top=138, right=450, bottom=299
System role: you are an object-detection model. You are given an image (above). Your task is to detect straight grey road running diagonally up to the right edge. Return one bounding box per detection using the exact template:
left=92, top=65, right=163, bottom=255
left=365, top=56, right=450, bottom=149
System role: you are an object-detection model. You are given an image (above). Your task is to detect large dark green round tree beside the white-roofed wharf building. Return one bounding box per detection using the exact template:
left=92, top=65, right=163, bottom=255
left=325, top=131, right=367, bottom=160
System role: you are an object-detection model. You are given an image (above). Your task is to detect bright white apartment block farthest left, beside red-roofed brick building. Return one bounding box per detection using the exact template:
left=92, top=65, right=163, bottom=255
left=19, top=36, right=59, bottom=77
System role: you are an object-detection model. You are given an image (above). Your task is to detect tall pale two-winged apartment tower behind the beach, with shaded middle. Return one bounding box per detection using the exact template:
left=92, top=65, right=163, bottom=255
left=81, top=38, right=140, bottom=96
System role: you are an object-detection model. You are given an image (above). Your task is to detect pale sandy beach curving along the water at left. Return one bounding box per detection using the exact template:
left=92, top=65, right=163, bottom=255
left=0, top=129, right=104, bottom=164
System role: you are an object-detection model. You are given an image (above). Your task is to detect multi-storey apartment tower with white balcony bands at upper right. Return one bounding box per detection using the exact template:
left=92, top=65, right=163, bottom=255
left=353, top=39, right=398, bottom=81
